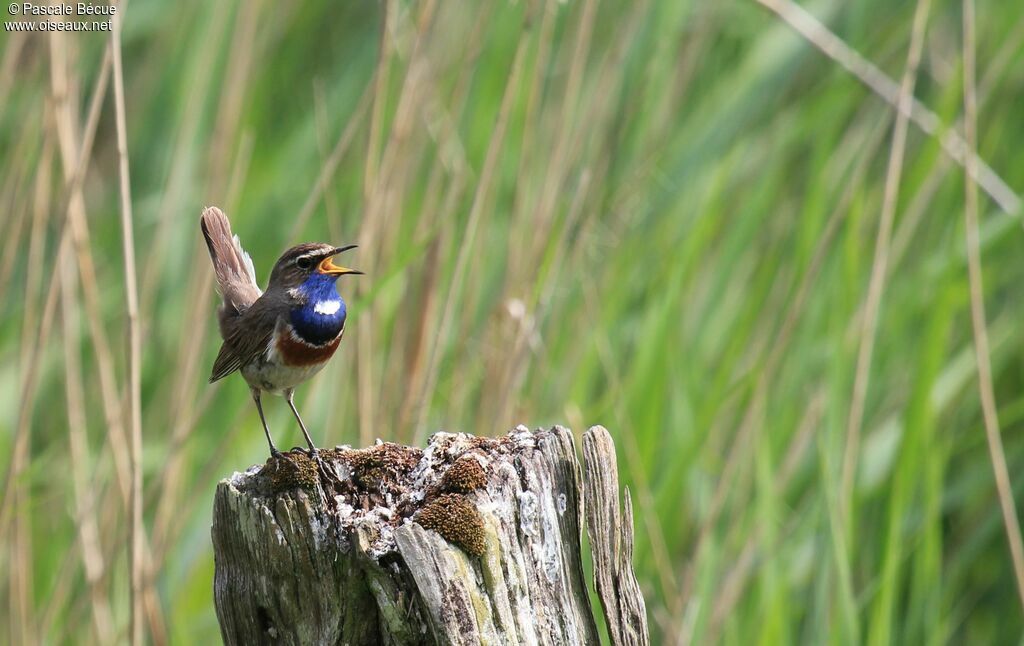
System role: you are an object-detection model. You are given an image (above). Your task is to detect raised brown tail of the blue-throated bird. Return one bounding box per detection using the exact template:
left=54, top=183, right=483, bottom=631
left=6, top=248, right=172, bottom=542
left=200, top=207, right=263, bottom=315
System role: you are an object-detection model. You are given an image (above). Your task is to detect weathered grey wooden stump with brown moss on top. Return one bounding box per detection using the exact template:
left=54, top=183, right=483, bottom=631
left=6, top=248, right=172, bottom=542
left=212, top=426, right=649, bottom=645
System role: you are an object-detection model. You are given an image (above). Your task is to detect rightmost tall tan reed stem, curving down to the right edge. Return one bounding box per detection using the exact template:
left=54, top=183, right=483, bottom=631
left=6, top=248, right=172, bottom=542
left=964, top=0, right=1024, bottom=607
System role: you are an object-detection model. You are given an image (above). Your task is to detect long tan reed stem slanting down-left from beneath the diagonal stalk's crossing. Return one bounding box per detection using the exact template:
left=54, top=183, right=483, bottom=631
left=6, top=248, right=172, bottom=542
left=839, top=0, right=931, bottom=530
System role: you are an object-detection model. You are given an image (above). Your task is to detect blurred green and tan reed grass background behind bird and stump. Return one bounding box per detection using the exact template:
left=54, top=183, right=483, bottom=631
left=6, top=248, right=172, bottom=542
left=0, top=0, right=1024, bottom=644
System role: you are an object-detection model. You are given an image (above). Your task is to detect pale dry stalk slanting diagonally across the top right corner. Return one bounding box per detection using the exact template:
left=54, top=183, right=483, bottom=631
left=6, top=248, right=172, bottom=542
left=757, top=0, right=1021, bottom=214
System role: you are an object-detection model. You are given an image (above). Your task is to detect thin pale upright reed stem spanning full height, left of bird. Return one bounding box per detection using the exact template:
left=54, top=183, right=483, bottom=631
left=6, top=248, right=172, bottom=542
left=111, top=11, right=145, bottom=646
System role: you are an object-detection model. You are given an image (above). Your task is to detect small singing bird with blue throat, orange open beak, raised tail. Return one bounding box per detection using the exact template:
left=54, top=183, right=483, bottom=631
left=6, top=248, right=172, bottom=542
left=200, top=207, right=362, bottom=458
